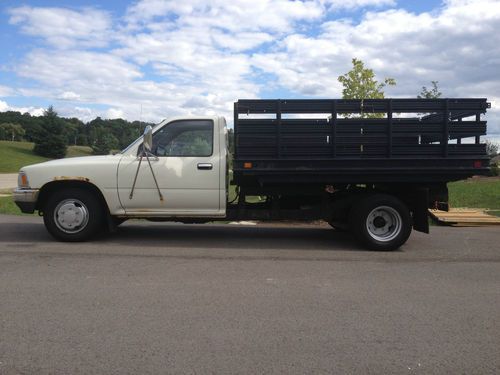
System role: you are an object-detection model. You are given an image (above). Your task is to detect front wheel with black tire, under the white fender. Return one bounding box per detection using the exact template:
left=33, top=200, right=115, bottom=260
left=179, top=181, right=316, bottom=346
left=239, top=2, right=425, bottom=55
left=43, top=188, right=105, bottom=242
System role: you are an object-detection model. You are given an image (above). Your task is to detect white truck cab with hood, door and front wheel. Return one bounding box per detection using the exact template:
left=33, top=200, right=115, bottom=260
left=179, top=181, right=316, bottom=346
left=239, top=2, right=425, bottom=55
left=14, top=116, right=228, bottom=241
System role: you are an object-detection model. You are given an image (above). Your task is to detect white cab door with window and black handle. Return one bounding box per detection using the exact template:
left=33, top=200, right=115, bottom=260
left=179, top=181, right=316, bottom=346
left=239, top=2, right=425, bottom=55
left=118, top=119, right=221, bottom=216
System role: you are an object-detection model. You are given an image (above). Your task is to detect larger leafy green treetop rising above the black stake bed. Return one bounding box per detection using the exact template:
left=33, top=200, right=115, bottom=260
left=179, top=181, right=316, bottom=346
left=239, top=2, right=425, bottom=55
left=338, top=58, right=396, bottom=117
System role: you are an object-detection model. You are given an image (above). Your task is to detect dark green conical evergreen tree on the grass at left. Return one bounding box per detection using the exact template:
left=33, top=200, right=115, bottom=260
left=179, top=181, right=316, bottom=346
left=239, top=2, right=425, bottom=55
left=33, top=106, right=66, bottom=159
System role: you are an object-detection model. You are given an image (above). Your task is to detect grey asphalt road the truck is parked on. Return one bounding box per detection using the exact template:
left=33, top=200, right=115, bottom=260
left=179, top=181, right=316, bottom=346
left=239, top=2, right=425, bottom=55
left=0, top=216, right=500, bottom=375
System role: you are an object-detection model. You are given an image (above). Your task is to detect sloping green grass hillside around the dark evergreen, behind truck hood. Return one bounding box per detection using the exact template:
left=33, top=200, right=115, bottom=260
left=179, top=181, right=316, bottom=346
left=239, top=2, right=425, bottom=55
left=0, top=141, right=92, bottom=173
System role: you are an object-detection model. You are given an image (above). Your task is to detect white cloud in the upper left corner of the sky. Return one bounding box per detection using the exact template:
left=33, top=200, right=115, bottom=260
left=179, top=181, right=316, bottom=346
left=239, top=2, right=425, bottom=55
left=9, top=6, right=111, bottom=48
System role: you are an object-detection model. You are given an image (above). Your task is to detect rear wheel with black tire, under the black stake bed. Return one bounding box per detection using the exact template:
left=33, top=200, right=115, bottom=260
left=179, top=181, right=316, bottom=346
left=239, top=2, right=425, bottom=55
left=349, top=194, right=412, bottom=251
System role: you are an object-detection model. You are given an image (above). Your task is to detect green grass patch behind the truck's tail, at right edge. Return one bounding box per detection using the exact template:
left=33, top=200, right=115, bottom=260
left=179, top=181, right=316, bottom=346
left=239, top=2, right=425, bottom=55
left=448, top=178, right=500, bottom=210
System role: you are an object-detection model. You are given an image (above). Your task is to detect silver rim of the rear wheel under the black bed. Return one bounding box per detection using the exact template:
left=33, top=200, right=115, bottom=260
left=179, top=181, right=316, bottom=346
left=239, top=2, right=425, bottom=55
left=366, top=206, right=403, bottom=242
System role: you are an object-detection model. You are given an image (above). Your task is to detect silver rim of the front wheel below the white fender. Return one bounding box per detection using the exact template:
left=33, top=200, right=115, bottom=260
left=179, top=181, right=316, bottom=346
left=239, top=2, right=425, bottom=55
left=54, top=199, right=89, bottom=233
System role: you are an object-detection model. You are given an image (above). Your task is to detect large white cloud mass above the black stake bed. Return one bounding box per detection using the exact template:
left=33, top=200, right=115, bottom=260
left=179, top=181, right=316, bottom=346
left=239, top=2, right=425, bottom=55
left=252, top=0, right=500, bottom=134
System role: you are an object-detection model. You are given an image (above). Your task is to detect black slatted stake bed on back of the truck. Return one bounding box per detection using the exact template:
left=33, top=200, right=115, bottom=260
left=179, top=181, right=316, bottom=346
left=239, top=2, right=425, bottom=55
left=234, top=98, right=490, bottom=186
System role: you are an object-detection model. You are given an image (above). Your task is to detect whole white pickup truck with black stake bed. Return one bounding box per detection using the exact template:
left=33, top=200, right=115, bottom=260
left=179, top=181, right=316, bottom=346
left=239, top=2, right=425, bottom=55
left=14, top=99, right=488, bottom=250
